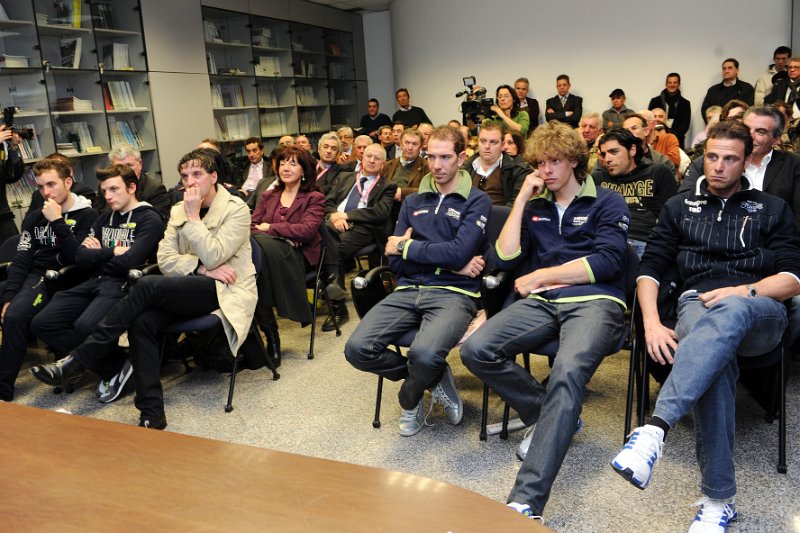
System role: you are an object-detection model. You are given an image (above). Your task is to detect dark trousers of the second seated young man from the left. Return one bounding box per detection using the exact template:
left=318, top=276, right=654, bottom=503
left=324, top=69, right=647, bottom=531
left=31, top=276, right=125, bottom=380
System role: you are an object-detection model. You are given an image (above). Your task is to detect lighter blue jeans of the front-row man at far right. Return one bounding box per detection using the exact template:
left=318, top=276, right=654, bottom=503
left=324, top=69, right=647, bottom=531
left=653, top=292, right=787, bottom=499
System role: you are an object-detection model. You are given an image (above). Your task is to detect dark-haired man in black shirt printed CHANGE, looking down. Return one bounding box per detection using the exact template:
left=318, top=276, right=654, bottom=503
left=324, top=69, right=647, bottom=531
left=592, top=128, right=678, bottom=257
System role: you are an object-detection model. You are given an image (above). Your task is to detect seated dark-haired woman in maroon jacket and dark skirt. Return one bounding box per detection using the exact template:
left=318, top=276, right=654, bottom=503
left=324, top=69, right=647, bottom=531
left=250, top=146, right=325, bottom=363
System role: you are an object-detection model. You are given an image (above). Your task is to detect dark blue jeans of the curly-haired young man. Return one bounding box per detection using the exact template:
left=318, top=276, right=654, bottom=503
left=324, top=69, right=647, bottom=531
left=461, top=298, right=624, bottom=514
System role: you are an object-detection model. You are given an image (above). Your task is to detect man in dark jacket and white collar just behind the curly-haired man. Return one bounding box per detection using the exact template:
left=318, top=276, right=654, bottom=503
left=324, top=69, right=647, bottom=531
left=461, top=122, right=531, bottom=206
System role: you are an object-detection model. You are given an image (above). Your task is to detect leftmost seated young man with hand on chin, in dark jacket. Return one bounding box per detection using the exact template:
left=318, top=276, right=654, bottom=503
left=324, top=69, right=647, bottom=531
left=0, top=158, right=97, bottom=402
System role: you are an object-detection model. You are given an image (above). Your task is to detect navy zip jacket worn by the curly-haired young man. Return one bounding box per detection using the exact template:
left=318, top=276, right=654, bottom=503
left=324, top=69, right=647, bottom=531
left=495, top=176, right=630, bottom=307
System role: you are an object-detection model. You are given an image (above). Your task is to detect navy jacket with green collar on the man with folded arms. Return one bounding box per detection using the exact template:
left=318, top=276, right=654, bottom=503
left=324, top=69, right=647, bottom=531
left=389, top=170, right=492, bottom=297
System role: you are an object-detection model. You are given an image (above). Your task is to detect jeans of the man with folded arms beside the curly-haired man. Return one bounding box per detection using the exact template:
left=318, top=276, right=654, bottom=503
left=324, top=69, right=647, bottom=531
left=344, top=287, right=476, bottom=409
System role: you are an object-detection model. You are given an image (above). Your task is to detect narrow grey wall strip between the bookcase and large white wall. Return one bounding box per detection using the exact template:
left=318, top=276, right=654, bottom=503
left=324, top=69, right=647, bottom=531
left=359, top=11, right=397, bottom=117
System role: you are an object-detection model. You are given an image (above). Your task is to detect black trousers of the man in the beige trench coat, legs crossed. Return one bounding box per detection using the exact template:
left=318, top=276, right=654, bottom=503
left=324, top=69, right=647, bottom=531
left=72, top=276, right=219, bottom=419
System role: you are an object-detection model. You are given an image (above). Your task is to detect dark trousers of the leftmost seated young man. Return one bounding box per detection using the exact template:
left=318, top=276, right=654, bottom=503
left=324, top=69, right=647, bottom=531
left=0, top=272, right=50, bottom=402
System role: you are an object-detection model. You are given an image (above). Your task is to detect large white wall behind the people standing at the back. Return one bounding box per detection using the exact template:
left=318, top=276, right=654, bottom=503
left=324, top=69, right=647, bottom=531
left=388, top=0, right=800, bottom=141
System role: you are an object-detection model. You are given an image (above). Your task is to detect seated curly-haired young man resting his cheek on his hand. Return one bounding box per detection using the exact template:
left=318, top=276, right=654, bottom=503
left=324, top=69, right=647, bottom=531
left=461, top=121, right=630, bottom=517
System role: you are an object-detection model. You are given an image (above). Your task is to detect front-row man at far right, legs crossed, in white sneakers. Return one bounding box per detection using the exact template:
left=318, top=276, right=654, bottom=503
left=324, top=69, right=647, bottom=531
left=611, top=121, right=800, bottom=533
